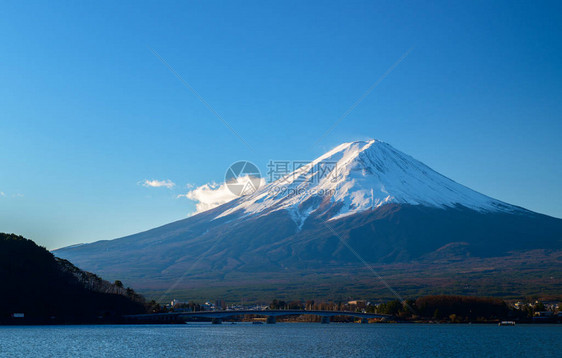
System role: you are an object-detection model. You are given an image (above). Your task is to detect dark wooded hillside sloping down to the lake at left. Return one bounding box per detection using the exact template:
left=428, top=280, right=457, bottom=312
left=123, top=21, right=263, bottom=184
left=0, top=233, right=145, bottom=324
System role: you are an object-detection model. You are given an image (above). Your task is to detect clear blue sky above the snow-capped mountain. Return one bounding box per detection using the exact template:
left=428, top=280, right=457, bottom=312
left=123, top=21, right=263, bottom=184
left=0, top=1, right=562, bottom=249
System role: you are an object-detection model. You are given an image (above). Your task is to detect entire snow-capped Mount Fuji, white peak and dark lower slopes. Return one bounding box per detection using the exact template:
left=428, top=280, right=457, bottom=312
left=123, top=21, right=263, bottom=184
left=54, top=140, right=562, bottom=299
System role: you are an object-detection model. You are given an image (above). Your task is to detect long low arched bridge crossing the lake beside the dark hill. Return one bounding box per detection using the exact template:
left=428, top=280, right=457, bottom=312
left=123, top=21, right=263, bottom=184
left=125, top=310, right=393, bottom=324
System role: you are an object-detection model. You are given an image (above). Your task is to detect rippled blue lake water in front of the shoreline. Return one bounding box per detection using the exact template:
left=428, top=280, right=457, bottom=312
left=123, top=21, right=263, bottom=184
left=0, top=323, right=562, bottom=358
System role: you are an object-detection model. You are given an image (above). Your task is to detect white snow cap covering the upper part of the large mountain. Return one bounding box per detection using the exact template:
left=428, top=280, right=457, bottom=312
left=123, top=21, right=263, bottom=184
left=217, top=140, right=519, bottom=227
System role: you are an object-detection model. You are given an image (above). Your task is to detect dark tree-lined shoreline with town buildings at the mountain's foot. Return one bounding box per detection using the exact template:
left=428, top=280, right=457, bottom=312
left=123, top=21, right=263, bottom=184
left=140, top=295, right=562, bottom=323
